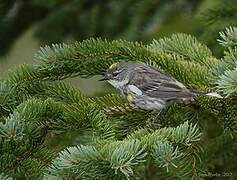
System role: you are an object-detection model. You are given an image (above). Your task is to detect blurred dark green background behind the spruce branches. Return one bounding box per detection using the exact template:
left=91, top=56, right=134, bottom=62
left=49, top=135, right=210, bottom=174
left=0, top=0, right=237, bottom=95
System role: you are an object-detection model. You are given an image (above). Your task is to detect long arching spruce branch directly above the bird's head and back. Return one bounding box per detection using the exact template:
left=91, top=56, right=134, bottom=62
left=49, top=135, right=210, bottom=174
left=32, top=39, right=214, bottom=89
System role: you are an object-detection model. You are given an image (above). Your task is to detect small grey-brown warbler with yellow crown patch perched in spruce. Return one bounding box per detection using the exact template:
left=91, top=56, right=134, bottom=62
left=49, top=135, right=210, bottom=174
left=101, top=61, right=222, bottom=110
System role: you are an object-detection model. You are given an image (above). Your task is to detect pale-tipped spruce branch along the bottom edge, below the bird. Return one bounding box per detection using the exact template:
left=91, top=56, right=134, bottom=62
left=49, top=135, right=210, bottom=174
left=45, top=122, right=201, bottom=179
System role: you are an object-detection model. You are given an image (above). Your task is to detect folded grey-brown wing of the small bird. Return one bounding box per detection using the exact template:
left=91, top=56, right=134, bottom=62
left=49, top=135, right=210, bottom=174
left=128, top=66, right=194, bottom=100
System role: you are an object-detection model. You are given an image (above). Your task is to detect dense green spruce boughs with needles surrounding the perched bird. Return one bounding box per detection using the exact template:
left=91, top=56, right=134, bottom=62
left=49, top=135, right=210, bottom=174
left=0, top=27, right=237, bottom=179
